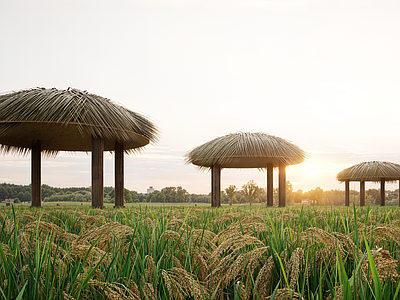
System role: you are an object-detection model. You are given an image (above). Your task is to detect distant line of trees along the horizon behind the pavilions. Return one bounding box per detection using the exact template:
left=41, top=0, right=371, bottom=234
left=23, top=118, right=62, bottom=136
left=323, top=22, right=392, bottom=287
left=0, top=180, right=398, bottom=205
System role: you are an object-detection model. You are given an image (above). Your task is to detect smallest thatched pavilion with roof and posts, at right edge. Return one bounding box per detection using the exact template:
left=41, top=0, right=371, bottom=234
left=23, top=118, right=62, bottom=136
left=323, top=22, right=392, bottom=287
left=336, top=161, right=400, bottom=206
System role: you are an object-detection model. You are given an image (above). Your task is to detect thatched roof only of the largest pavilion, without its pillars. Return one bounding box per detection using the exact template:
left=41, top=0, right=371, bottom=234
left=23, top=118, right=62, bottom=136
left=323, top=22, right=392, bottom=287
left=0, top=88, right=158, bottom=154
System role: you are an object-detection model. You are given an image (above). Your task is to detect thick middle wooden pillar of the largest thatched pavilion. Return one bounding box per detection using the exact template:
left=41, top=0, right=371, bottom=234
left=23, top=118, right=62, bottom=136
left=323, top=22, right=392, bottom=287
left=92, top=136, right=104, bottom=208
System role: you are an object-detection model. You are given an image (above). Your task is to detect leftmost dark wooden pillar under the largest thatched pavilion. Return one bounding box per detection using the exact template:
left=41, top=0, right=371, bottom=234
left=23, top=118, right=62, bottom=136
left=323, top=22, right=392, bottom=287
left=31, top=141, right=42, bottom=207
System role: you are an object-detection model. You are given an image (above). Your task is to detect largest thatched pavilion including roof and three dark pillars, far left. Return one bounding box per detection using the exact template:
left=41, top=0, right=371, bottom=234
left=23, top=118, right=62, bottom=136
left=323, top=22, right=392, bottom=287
left=0, top=88, right=158, bottom=207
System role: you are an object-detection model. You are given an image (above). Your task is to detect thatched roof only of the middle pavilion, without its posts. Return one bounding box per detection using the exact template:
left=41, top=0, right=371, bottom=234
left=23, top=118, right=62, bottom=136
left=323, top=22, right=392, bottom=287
left=185, top=132, right=306, bottom=169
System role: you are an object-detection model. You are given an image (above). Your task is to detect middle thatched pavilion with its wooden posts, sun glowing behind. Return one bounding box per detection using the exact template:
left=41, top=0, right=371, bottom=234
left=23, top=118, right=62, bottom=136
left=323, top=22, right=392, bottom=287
left=185, top=132, right=306, bottom=206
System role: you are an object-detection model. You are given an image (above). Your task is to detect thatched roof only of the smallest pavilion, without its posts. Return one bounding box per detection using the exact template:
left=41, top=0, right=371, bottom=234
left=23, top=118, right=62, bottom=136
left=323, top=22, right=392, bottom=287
left=336, top=161, right=400, bottom=182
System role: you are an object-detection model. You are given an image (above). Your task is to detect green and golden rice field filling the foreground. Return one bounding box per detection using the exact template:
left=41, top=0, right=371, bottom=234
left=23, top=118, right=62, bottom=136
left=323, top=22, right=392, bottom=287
left=0, top=206, right=400, bottom=300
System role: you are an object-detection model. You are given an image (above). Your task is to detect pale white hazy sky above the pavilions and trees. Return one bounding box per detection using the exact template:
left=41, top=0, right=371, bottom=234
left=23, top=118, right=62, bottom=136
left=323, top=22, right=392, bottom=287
left=0, top=0, right=400, bottom=194
